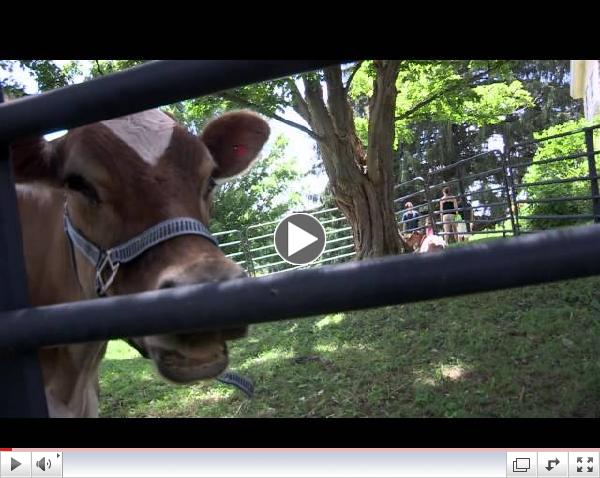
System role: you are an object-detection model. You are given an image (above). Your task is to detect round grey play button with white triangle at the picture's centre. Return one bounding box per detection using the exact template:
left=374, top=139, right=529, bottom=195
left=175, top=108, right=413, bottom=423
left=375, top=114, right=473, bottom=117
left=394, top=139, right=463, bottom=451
left=275, top=213, right=326, bottom=265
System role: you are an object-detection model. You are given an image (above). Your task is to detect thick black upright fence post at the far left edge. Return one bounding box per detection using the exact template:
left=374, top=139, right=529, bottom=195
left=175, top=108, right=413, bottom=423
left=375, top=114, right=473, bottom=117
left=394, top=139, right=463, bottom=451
left=0, top=89, right=48, bottom=417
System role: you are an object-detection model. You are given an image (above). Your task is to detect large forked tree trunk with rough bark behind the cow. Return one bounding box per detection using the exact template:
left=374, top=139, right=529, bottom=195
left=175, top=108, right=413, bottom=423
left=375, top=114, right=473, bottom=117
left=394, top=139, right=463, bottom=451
left=295, top=61, right=403, bottom=259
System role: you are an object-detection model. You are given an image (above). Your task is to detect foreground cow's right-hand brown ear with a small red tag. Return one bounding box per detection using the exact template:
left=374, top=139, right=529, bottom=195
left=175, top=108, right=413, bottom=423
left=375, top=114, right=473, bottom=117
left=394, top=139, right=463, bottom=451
left=201, top=111, right=271, bottom=179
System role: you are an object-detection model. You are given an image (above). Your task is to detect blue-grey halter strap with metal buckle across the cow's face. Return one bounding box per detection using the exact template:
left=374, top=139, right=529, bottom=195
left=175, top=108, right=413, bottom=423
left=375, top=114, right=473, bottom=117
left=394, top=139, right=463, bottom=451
left=64, top=211, right=219, bottom=297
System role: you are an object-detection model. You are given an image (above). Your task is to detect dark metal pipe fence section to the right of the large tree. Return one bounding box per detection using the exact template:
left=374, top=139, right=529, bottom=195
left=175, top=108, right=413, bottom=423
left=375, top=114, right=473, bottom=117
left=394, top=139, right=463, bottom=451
left=395, top=125, right=600, bottom=243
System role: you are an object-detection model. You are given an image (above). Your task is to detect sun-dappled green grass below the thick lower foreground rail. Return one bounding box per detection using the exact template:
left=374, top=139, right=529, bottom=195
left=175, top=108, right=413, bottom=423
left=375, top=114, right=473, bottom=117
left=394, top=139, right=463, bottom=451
left=100, top=277, right=600, bottom=417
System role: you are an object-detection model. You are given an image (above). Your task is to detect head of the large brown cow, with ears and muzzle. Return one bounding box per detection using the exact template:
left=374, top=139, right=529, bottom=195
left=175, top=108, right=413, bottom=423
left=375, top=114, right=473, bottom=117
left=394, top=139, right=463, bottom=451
left=12, top=110, right=269, bottom=383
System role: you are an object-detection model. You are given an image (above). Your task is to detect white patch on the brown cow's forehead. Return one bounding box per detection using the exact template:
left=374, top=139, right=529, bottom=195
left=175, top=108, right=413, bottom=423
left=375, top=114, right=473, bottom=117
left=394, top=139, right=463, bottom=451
left=101, top=109, right=177, bottom=166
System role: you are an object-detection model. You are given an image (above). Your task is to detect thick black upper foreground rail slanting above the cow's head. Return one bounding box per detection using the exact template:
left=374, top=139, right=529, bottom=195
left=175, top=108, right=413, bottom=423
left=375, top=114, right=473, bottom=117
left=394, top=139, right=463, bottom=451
left=0, top=60, right=344, bottom=142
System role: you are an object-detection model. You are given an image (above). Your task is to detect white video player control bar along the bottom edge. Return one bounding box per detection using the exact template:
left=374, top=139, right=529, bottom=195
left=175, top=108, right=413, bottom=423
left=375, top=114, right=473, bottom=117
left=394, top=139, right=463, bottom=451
left=0, top=449, right=598, bottom=478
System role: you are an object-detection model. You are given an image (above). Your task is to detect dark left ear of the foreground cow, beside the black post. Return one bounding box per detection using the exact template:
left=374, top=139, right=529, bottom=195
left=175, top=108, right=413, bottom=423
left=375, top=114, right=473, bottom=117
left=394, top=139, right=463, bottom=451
left=10, top=137, right=62, bottom=187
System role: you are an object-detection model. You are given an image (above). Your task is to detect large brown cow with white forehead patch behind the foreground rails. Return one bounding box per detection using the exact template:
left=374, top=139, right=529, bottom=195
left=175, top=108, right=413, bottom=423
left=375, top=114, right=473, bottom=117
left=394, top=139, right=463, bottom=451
left=11, top=106, right=270, bottom=417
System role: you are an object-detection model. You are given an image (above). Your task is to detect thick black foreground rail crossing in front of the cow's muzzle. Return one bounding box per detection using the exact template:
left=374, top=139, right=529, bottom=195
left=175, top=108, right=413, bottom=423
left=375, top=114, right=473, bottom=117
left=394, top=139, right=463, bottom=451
left=0, top=225, right=600, bottom=352
